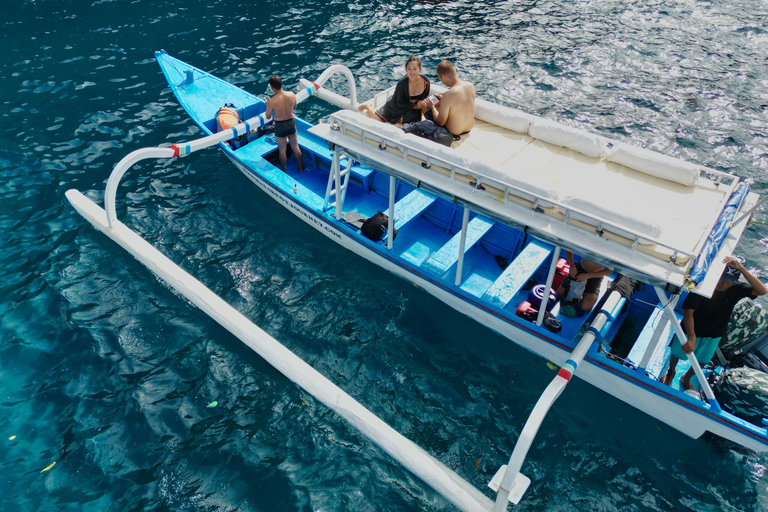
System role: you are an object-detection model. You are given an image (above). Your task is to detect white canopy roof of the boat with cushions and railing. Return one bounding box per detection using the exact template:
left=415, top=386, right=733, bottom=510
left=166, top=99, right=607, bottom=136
left=311, top=96, right=757, bottom=295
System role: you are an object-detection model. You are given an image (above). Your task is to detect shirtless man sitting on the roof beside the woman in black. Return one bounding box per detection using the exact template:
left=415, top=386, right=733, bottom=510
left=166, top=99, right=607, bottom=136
left=424, top=60, right=475, bottom=135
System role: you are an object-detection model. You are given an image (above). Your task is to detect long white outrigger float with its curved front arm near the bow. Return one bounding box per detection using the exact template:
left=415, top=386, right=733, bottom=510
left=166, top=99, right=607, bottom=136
left=65, top=63, right=493, bottom=512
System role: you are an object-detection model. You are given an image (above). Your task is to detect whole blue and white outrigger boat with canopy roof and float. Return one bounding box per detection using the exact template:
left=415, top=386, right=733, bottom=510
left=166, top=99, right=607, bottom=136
left=66, top=51, right=768, bottom=511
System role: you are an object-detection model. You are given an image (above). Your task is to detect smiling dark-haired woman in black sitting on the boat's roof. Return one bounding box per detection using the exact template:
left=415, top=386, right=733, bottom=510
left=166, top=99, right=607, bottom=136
left=358, top=57, right=429, bottom=124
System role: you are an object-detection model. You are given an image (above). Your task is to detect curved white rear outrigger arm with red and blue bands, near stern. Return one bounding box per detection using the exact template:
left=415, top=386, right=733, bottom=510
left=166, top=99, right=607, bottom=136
left=488, top=291, right=622, bottom=512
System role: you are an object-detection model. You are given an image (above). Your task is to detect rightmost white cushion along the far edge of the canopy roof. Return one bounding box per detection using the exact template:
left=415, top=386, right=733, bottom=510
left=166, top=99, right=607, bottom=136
left=606, top=143, right=700, bottom=187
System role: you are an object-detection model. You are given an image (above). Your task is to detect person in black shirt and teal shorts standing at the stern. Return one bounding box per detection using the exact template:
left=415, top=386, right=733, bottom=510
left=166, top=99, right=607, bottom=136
left=659, top=256, right=768, bottom=389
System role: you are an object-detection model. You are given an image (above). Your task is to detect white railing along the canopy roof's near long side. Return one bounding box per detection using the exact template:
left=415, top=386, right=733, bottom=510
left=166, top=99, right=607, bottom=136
left=331, top=110, right=695, bottom=265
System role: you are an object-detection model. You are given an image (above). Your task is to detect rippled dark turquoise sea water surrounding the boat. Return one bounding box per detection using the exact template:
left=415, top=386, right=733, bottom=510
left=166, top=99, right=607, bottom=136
left=0, top=0, right=768, bottom=512
